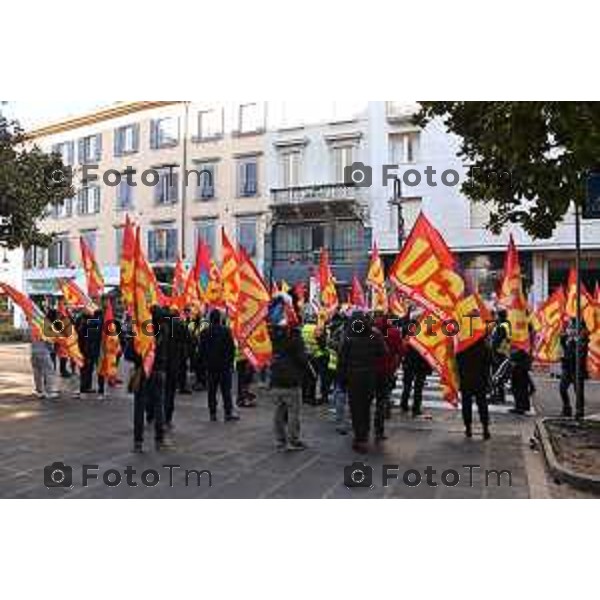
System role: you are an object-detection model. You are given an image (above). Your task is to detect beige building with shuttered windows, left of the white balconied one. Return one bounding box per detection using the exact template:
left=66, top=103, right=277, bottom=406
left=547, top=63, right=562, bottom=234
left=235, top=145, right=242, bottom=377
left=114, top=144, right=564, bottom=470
left=24, top=101, right=269, bottom=294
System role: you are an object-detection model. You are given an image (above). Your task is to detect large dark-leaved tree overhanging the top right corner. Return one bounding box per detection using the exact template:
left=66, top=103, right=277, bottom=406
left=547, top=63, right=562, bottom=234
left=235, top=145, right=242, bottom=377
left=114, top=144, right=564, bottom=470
left=416, top=102, right=600, bottom=238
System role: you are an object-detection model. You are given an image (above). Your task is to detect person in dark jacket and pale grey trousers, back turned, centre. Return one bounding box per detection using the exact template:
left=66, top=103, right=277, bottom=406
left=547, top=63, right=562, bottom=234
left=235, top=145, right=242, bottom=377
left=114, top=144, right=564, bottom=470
left=270, top=319, right=312, bottom=450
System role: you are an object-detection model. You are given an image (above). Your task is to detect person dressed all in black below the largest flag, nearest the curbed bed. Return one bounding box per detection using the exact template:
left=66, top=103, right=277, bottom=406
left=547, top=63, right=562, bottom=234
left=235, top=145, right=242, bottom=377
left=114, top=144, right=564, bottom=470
left=456, top=337, right=492, bottom=440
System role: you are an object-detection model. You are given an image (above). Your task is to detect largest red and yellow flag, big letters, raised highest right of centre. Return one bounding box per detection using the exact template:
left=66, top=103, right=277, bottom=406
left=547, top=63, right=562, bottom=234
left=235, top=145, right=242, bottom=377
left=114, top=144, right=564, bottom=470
left=389, top=213, right=465, bottom=319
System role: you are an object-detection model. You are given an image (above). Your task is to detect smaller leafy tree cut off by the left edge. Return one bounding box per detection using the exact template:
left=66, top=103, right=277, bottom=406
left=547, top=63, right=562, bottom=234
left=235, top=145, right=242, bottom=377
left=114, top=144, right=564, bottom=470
left=0, top=105, right=74, bottom=249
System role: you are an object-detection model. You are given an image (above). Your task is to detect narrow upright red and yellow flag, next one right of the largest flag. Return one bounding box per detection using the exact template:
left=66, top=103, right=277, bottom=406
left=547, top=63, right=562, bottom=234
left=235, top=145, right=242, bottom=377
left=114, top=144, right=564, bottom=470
left=498, top=235, right=531, bottom=351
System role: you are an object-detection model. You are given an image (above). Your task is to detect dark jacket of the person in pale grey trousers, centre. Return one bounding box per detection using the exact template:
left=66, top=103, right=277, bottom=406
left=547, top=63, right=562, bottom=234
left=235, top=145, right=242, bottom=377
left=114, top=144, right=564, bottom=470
left=271, top=327, right=310, bottom=388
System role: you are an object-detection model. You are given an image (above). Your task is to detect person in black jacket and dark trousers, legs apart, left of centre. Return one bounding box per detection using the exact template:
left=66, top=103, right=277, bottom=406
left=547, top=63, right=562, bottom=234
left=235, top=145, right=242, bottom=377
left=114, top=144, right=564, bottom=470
left=200, top=309, right=239, bottom=421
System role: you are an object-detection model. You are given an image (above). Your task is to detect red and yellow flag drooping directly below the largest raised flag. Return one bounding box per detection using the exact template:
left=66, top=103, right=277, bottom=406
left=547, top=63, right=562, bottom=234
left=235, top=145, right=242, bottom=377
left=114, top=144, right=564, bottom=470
left=408, top=312, right=459, bottom=406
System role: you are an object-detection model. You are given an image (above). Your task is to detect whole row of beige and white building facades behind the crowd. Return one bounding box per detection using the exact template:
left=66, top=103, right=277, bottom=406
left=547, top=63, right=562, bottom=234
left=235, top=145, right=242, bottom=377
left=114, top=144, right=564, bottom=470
left=18, top=101, right=600, bottom=303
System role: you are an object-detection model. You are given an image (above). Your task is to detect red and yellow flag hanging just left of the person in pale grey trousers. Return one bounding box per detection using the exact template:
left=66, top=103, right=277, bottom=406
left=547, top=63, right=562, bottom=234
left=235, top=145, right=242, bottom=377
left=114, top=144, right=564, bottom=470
left=234, top=248, right=273, bottom=369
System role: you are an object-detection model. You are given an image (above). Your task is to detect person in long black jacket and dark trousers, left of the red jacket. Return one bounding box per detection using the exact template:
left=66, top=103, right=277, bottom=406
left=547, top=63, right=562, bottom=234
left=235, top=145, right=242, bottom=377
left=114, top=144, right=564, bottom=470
left=338, top=312, right=385, bottom=453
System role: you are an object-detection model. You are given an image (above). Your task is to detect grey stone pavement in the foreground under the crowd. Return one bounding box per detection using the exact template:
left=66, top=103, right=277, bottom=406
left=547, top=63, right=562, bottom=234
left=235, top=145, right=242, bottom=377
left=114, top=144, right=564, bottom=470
left=0, top=346, right=587, bottom=498
